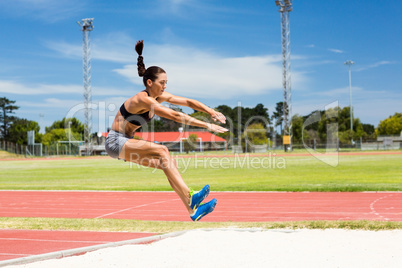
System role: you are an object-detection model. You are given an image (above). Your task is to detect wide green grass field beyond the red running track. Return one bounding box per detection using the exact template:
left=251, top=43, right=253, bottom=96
left=0, top=154, right=402, bottom=191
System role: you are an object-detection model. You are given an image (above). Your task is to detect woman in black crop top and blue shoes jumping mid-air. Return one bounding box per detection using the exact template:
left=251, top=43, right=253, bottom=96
left=105, top=40, right=228, bottom=221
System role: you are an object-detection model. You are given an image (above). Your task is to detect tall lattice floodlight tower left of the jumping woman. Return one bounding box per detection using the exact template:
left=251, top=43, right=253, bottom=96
left=77, top=18, right=94, bottom=155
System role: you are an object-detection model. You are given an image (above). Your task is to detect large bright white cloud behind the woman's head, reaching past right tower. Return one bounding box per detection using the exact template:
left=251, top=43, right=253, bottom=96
left=115, top=45, right=306, bottom=99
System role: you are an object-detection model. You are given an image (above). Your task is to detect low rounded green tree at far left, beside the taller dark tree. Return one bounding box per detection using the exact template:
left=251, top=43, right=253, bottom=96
left=8, top=118, right=42, bottom=145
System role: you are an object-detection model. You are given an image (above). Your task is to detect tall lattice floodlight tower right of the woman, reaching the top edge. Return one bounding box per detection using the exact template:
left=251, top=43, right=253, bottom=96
left=275, top=0, right=293, bottom=152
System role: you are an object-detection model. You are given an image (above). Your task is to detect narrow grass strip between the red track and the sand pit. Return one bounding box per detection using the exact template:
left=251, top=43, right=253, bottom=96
left=0, top=218, right=402, bottom=233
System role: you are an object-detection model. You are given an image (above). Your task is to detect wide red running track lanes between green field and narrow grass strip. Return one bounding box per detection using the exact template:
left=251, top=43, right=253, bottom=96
left=0, top=191, right=402, bottom=222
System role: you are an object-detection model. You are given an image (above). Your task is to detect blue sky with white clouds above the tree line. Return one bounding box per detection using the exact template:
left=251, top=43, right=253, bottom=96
left=0, top=0, right=402, bottom=132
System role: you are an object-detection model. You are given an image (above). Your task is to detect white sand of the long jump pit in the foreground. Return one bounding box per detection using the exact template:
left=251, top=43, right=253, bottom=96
left=12, top=229, right=402, bottom=268
